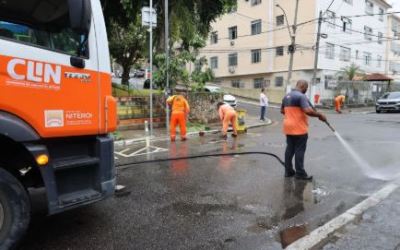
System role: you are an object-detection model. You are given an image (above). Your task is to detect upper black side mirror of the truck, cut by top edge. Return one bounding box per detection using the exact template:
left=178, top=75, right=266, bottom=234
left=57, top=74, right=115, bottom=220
left=68, top=0, right=92, bottom=35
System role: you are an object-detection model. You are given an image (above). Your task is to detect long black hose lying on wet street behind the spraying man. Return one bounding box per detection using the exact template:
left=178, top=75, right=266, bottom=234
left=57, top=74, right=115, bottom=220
left=116, top=151, right=285, bottom=168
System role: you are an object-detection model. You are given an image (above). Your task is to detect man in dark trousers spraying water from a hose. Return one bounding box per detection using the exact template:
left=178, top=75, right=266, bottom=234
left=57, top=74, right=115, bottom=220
left=281, top=80, right=327, bottom=180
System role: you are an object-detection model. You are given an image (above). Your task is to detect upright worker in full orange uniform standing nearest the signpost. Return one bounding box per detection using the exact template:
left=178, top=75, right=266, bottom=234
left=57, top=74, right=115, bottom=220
left=167, top=95, right=190, bottom=141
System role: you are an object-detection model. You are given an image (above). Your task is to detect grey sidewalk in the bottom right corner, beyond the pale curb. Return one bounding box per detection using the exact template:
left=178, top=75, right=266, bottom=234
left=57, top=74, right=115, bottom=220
left=323, top=189, right=400, bottom=250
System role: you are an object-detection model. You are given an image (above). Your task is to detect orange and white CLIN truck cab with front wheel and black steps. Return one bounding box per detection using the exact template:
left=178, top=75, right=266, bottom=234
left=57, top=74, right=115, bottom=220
left=0, top=0, right=117, bottom=249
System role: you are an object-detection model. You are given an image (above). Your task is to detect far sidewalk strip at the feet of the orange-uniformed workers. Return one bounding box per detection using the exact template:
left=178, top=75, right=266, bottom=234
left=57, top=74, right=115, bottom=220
left=117, top=116, right=272, bottom=142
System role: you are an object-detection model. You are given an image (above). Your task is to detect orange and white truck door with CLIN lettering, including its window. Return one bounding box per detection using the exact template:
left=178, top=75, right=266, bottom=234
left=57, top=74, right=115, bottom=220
left=0, top=0, right=100, bottom=138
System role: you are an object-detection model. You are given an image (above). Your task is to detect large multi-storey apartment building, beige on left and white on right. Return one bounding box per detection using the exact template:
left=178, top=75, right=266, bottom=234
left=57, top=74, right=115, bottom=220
left=201, top=0, right=391, bottom=101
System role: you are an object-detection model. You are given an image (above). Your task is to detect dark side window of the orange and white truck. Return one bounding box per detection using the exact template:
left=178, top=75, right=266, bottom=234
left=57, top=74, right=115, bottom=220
left=0, top=0, right=89, bottom=58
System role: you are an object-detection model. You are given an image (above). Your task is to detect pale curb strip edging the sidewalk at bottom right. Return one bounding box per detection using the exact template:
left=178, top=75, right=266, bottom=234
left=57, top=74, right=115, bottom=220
left=286, top=182, right=399, bottom=250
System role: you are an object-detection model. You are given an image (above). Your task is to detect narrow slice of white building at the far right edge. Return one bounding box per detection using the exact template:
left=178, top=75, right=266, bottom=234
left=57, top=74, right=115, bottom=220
left=386, top=15, right=400, bottom=81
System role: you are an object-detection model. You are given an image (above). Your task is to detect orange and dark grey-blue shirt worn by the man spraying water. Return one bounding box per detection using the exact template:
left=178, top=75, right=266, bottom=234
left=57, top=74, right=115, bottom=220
left=282, top=90, right=311, bottom=135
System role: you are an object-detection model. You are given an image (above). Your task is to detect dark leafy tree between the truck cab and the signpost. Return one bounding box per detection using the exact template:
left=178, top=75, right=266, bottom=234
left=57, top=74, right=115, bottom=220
left=103, top=0, right=147, bottom=85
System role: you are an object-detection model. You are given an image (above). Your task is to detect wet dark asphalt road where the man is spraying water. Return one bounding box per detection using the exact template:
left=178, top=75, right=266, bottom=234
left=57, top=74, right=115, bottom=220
left=20, top=106, right=400, bottom=250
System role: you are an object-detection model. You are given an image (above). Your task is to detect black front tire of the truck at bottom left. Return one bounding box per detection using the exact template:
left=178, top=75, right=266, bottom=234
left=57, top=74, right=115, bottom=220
left=0, top=168, right=30, bottom=249
